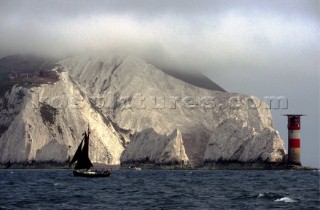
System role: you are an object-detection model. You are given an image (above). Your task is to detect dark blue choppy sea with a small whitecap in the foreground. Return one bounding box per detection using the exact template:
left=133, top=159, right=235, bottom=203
left=0, top=169, right=320, bottom=210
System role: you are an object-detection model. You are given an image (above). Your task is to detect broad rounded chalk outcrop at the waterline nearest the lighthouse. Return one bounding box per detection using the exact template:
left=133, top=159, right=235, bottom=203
left=204, top=119, right=285, bottom=163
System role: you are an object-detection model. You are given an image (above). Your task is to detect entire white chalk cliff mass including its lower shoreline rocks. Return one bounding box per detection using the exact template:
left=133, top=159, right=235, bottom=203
left=0, top=55, right=284, bottom=165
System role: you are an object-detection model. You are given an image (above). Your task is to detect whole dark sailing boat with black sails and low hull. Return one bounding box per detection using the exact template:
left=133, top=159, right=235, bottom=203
left=69, top=127, right=110, bottom=177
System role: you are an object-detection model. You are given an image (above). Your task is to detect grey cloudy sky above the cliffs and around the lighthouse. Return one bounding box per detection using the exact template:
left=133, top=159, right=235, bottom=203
left=0, top=0, right=320, bottom=167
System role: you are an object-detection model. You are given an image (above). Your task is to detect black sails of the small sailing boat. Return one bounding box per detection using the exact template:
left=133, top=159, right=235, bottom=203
left=70, top=132, right=92, bottom=169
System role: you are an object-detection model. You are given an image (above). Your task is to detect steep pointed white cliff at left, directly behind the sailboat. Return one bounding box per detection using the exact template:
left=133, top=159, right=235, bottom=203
left=0, top=69, right=124, bottom=164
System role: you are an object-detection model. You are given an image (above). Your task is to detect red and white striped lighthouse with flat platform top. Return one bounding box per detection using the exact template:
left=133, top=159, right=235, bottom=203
left=286, top=114, right=304, bottom=165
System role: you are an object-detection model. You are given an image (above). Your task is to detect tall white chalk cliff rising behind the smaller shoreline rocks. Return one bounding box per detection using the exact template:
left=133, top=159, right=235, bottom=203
left=60, top=55, right=283, bottom=165
